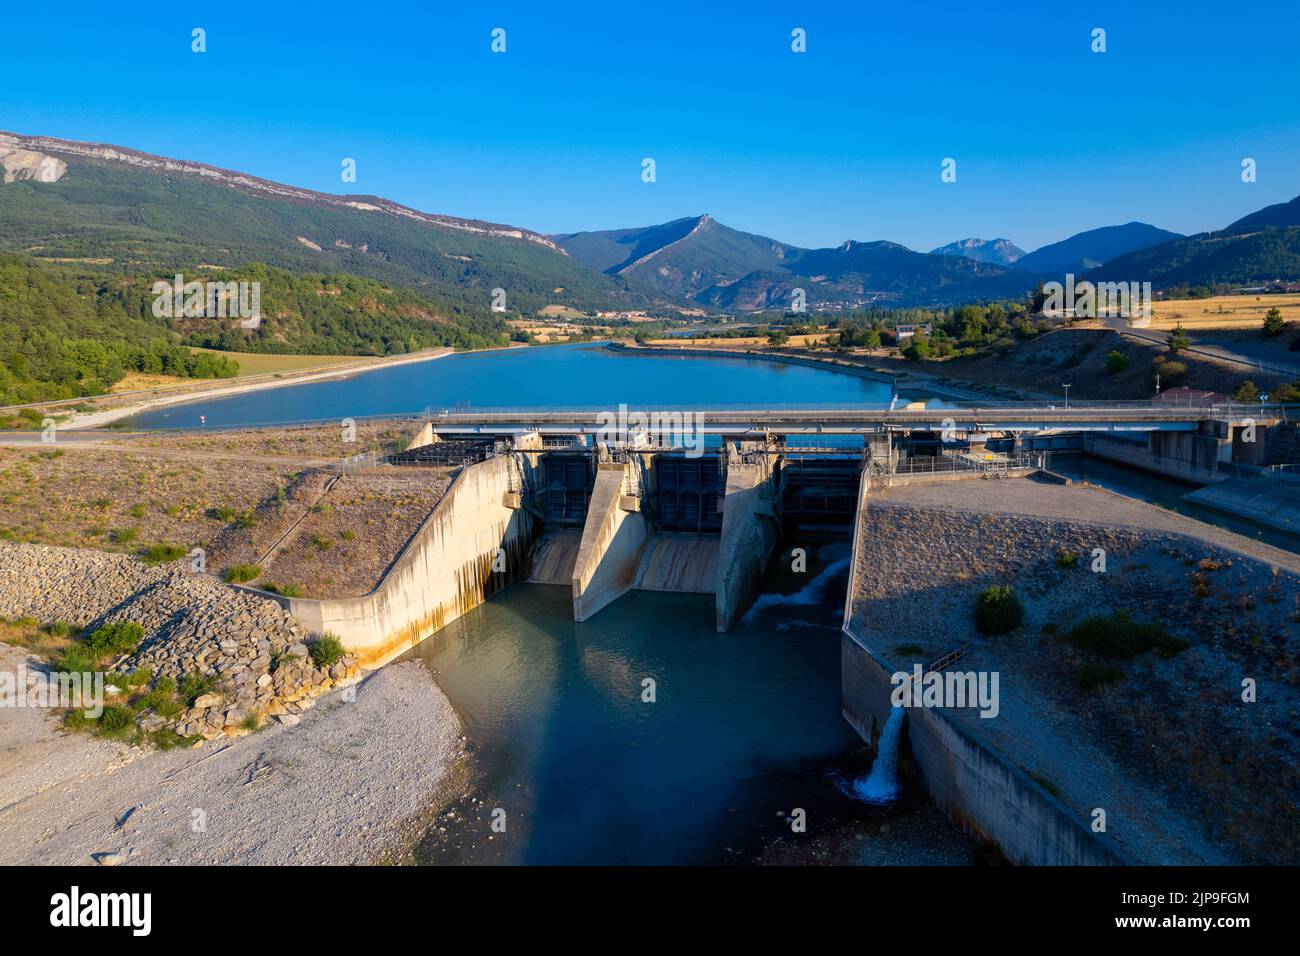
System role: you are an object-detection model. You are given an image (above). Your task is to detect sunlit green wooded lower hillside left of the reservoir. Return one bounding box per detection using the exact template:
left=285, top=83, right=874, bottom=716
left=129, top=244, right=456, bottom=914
left=0, top=256, right=507, bottom=405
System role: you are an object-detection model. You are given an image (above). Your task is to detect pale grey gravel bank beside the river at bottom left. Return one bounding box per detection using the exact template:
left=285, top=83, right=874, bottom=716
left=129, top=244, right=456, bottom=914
left=0, top=645, right=462, bottom=865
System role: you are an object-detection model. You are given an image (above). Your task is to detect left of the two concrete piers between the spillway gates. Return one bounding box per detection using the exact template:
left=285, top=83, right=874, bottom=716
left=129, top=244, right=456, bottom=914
left=573, top=462, right=651, bottom=620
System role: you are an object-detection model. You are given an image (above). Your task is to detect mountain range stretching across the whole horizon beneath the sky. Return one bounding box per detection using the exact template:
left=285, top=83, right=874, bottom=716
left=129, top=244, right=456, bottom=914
left=0, top=133, right=1300, bottom=323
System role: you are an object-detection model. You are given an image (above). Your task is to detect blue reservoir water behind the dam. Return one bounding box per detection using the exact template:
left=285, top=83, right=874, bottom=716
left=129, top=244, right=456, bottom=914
left=125, top=343, right=891, bottom=428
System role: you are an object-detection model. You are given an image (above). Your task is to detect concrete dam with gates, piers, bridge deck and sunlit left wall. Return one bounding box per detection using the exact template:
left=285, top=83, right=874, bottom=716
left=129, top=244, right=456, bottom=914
left=258, top=402, right=1296, bottom=666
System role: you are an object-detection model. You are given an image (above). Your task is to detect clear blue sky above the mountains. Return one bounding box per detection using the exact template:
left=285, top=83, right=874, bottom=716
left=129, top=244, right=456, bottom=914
left=0, top=0, right=1300, bottom=250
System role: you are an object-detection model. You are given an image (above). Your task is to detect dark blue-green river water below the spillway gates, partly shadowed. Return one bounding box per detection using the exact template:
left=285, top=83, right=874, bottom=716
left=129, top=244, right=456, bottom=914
left=408, top=544, right=972, bottom=865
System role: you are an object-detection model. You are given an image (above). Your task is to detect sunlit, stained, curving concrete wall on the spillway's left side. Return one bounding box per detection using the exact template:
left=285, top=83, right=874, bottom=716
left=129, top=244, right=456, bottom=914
left=250, top=455, right=536, bottom=667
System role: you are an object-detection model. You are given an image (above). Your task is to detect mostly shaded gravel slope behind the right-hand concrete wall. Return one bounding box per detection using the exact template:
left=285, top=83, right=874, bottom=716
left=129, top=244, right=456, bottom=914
left=854, top=479, right=1300, bottom=864
